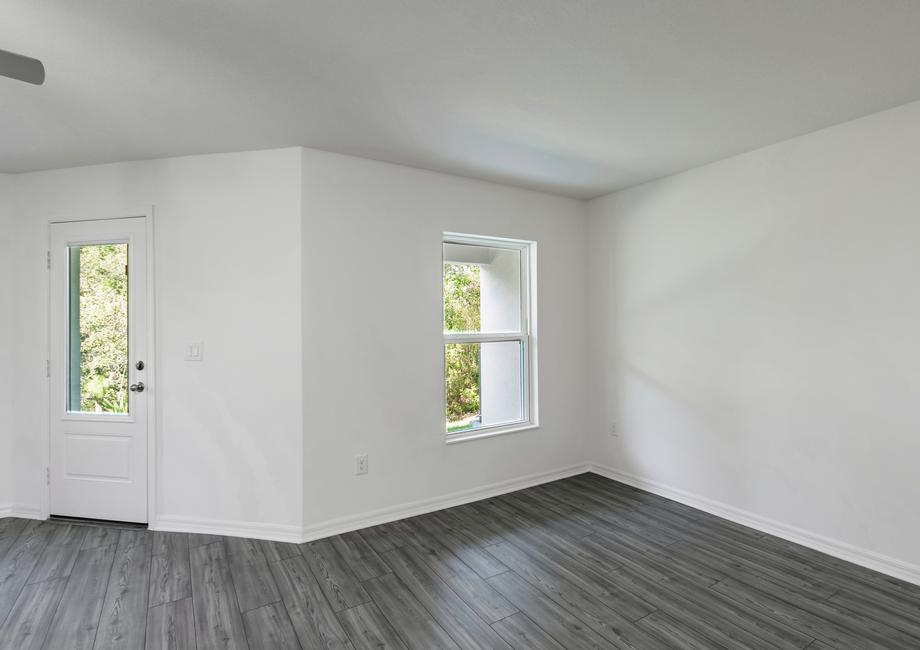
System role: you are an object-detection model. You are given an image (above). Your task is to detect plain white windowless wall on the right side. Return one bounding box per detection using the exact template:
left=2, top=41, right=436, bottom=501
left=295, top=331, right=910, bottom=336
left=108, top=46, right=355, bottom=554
left=588, top=98, right=920, bottom=567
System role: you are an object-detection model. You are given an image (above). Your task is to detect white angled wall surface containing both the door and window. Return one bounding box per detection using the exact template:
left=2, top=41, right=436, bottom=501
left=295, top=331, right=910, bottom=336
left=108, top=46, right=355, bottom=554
left=0, top=148, right=586, bottom=537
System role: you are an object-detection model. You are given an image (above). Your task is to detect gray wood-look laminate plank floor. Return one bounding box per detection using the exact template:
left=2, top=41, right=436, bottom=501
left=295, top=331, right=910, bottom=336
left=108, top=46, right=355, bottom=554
left=0, top=474, right=920, bottom=650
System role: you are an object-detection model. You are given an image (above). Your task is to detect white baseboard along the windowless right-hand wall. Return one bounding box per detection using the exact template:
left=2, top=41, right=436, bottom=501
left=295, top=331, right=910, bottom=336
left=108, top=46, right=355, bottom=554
left=589, top=465, right=920, bottom=585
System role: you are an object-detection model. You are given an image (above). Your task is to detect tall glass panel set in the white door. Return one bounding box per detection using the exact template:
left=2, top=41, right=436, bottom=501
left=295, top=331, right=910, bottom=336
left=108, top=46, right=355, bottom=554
left=67, top=243, right=128, bottom=414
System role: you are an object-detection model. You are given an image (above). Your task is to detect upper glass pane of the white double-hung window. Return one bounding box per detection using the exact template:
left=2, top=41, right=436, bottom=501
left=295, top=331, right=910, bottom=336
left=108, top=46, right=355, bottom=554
left=444, top=244, right=521, bottom=332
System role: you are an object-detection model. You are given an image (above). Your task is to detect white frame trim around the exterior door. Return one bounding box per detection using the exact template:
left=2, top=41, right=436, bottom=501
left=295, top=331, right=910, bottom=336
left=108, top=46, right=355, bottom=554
left=38, top=206, right=160, bottom=528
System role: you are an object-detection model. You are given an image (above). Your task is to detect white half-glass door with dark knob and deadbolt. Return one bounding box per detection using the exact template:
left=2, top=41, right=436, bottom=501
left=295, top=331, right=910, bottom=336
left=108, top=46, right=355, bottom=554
left=49, top=217, right=152, bottom=523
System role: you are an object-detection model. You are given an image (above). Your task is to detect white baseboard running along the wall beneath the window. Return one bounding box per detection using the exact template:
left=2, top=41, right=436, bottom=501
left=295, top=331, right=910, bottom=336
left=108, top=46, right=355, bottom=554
left=302, top=464, right=589, bottom=542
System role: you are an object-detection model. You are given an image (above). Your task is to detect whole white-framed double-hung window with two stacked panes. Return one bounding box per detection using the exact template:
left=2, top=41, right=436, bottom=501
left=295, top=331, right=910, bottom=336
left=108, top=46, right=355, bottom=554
left=443, top=233, right=536, bottom=441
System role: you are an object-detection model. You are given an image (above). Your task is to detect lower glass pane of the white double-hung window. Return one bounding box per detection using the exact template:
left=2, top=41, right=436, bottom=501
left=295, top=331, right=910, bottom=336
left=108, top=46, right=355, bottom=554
left=444, top=341, right=524, bottom=433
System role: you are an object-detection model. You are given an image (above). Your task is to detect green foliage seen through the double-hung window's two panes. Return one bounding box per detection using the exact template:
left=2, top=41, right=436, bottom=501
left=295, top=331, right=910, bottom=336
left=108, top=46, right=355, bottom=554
left=444, top=264, right=480, bottom=420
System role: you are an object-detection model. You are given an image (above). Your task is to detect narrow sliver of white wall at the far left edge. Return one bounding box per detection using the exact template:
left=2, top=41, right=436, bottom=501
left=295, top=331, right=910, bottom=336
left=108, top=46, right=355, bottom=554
left=0, top=174, right=14, bottom=512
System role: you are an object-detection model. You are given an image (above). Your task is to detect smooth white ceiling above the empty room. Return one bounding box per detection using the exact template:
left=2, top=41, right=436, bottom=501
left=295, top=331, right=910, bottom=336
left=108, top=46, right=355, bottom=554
left=0, top=0, right=920, bottom=197
